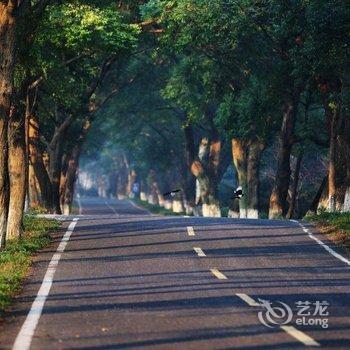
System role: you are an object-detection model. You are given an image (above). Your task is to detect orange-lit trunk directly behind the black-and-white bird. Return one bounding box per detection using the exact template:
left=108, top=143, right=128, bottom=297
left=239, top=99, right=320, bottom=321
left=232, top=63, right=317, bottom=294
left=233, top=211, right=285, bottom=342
left=231, top=139, right=249, bottom=218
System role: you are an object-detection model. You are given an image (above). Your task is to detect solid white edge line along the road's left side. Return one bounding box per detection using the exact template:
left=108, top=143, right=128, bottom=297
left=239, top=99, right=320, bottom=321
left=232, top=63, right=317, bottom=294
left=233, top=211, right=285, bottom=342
left=12, top=218, right=79, bottom=350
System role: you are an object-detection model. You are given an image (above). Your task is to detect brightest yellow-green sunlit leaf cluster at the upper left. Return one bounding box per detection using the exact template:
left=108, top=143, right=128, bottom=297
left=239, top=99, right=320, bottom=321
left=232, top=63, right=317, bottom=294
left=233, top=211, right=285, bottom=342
left=37, top=1, right=139, bottom=60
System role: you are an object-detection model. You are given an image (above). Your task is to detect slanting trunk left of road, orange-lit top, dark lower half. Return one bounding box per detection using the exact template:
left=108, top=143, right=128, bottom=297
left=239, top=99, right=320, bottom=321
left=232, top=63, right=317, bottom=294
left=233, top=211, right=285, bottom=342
left=28, top=114, right=52, bottom=213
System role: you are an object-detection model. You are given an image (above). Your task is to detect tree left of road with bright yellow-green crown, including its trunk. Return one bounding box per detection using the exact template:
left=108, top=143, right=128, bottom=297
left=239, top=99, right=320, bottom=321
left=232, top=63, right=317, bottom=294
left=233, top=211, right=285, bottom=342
left=26, top=2, right=138, bottom=213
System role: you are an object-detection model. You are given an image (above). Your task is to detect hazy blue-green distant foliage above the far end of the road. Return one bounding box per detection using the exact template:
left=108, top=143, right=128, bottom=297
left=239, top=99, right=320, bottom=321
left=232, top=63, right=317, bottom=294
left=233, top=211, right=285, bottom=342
left=82, top=46, right=183, bottom=182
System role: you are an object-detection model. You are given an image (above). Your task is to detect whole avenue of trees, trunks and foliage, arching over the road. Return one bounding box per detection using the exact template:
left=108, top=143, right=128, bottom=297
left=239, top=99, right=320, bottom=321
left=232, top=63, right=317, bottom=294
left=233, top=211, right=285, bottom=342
left=0, top=0, right=350, bottom=246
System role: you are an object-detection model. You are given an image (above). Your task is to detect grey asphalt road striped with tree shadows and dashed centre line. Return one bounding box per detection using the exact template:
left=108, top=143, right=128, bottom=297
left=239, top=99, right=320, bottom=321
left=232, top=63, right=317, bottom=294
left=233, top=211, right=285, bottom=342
left=0, top=199, right=350, bottom=349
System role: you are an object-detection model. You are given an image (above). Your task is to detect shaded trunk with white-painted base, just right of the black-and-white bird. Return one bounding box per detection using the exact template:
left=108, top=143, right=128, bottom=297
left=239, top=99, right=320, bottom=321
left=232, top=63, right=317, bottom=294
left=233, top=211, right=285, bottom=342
left=246, top=141, right=265, bottom=219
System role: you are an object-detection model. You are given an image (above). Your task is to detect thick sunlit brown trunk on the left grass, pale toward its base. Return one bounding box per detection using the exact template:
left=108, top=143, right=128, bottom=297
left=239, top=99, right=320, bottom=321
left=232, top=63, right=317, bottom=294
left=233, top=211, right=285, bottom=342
left=7, top=108, right=28, bottom=239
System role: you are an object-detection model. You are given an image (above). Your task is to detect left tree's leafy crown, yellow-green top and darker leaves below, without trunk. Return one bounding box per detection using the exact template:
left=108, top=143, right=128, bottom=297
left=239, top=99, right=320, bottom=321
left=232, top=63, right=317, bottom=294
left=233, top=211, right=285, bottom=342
left=26, top=1, right=140, bottom=146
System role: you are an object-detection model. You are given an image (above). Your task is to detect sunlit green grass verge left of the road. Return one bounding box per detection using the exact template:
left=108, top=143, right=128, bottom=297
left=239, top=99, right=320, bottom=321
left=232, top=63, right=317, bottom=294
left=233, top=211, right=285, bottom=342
left=0, top=215, right=60, bottom=316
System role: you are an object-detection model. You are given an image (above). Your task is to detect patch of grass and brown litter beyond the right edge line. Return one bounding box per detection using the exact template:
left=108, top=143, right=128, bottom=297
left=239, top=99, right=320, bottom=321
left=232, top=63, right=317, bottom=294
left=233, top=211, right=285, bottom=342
left=305, top=211, right=350, bottom=252
